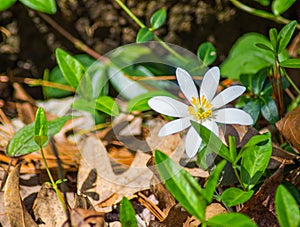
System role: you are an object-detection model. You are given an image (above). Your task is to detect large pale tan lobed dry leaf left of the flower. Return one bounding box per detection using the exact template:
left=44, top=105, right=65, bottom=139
left=77, top=137, right=152, bottom=209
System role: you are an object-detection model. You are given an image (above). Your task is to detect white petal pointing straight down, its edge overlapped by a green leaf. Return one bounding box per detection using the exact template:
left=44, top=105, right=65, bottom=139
left=185, top=127, right=202, bottom=158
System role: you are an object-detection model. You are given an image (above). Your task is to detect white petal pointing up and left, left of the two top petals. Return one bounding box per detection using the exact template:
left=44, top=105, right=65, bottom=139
left=176, top=68, right=199, bottom=101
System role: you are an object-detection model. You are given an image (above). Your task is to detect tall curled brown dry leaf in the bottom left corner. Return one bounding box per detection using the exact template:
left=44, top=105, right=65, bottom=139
left=4, top=164, right=37, bottom=227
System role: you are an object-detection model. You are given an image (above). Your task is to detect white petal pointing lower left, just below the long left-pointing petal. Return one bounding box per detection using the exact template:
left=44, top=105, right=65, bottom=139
left=158, top=117, right=191, bottom=136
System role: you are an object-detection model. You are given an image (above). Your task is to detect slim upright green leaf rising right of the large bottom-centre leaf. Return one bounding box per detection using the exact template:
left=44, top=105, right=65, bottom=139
left=203, top=160, right=226, bottom=204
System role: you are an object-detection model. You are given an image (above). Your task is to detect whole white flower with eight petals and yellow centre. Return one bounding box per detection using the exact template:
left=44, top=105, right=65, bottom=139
left=148, top=67, right=253, bottom=157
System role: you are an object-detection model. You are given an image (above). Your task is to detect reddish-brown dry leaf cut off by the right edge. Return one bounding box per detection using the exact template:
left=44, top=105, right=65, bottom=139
left=276, top=106, right=300, bottom=153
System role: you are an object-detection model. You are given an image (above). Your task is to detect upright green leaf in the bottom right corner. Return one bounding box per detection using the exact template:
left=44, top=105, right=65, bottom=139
left=275, top=185, right=300, bottom=227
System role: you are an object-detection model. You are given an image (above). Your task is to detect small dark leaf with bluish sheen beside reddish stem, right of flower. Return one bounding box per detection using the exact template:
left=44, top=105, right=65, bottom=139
left=260, top=96, right=279, bottom=124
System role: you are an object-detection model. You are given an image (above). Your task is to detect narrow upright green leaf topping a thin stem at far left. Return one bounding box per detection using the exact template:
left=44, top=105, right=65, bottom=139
left=34, top=107, right=48, bottom=147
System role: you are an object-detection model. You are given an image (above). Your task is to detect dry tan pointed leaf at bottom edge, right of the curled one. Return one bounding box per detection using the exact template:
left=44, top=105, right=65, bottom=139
left=32, top=183, right=67, bottom=227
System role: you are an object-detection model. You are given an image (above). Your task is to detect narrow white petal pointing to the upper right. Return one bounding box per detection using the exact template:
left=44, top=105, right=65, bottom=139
left=211, top=86, right=246, bottom=109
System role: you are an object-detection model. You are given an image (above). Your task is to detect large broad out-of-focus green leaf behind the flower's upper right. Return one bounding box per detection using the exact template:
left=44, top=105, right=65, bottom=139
left=220, top=33, right=274, bottom=79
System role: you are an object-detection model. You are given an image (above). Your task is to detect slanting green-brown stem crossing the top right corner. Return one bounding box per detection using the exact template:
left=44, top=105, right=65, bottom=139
left=230, top=0, right=300, bottom=30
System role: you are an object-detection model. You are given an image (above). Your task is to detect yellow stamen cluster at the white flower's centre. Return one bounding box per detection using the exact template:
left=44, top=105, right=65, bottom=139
left=188, top=95, right=212, bottom=121
